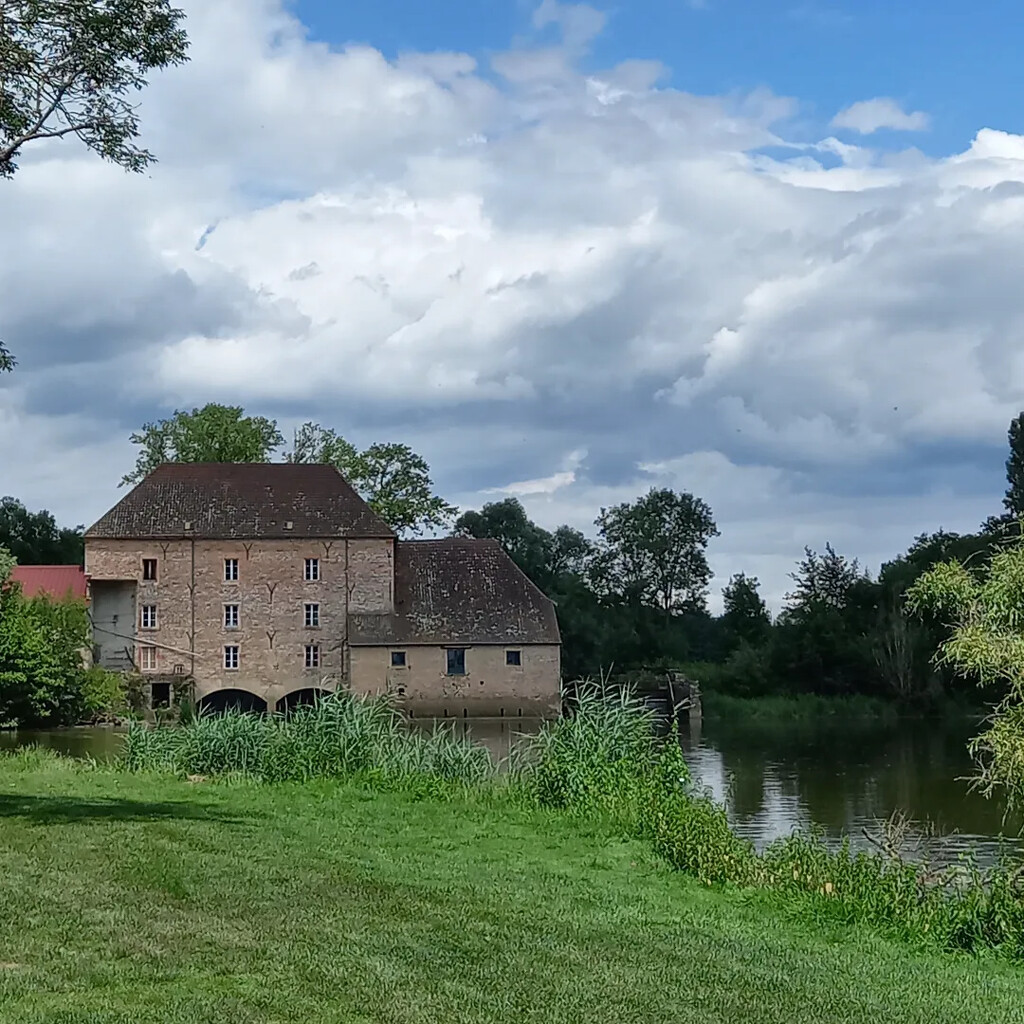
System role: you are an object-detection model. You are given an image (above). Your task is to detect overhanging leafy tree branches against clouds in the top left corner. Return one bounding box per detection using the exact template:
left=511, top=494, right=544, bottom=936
left=0, top=0, right=188, bottom=177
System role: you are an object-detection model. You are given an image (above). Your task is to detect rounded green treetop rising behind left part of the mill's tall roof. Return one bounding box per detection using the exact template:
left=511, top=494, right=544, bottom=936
left=121, top=402, right=285, bottom=485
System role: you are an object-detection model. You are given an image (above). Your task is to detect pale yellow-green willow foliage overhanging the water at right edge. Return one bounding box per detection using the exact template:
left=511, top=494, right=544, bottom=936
left=907, top=540, right=1024, bottom=807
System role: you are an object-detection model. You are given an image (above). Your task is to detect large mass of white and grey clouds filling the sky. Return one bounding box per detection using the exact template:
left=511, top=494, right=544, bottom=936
left=0, top=0, right=1024, bottom=601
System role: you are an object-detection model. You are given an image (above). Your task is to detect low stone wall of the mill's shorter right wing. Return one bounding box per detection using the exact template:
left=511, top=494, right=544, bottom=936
left=350, top=644, right=561, bottom=718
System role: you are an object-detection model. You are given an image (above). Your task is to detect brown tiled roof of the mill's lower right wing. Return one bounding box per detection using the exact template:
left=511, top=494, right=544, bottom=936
left=348, top=538, right=559, bottom=647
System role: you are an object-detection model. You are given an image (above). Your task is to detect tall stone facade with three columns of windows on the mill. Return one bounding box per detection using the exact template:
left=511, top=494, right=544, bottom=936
left=86, top=538, right=393, bottom=709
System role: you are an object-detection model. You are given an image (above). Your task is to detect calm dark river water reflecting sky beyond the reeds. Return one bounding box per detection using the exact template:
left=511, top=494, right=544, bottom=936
left=0, top=719, right=1024, bottom=863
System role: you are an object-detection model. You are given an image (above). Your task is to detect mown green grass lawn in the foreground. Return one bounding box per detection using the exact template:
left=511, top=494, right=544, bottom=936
left=0, top=758, right=1024, bottom=1024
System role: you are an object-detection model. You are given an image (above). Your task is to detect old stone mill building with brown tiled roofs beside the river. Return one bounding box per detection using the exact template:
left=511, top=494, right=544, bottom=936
left=85, top=463, right=559, bottom=717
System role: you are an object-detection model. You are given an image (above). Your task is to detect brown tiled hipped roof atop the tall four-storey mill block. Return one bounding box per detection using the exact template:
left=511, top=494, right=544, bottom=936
left=85, top=462, right=394, bottom=540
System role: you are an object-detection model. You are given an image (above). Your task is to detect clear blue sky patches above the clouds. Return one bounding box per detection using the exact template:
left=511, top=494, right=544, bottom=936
left=294, top=0, right=1024, bottom=154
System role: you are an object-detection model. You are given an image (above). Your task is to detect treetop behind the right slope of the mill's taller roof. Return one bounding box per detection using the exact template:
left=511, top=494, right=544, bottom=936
left=286, top=423, right=458, bottom=537
